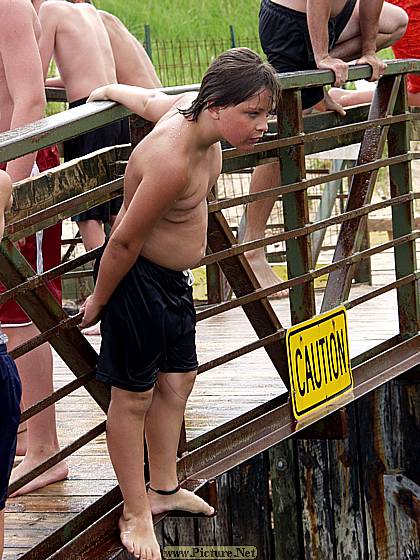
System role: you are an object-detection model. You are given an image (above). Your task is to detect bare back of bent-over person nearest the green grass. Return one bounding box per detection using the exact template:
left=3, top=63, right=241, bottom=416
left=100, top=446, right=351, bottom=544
left=98, top=10, right=162, bottom=88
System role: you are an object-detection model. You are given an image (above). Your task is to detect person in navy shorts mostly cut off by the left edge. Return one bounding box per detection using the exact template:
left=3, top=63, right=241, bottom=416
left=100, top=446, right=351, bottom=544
left=0, top=171, right=21, bottom=558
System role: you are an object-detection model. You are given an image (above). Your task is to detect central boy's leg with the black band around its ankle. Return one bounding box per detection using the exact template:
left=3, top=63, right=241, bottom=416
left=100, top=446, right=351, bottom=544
left=146, top=371, right=214, bottom=515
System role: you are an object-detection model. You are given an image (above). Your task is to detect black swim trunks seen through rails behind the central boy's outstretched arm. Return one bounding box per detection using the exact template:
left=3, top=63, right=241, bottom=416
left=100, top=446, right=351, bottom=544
left=63, top=97, right=130, bottom=223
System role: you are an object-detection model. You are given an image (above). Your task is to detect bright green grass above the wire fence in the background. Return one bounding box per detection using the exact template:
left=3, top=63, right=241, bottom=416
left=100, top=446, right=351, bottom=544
left=95, top=0, right=260, bottom=40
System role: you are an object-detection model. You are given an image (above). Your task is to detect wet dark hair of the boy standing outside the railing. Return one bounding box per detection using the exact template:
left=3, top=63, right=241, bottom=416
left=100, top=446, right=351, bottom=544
left=179, top=47, right=280, bottom=121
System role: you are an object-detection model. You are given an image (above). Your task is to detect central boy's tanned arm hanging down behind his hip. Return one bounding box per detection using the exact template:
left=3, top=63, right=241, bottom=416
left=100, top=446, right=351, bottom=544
left=81, top=158, right=188, bottom=328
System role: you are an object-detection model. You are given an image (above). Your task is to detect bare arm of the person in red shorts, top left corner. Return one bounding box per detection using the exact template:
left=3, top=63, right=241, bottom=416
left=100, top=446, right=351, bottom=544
left=0, top=0, right=45, bottom=182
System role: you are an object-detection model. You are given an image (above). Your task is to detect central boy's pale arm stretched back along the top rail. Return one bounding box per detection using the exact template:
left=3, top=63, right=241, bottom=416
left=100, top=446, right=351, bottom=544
left=87, top=84, right=191, bottom=122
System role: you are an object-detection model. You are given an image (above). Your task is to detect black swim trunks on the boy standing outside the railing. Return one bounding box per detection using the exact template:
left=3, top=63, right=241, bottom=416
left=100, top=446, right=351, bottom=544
left=95, top=250, right=198, bottom=392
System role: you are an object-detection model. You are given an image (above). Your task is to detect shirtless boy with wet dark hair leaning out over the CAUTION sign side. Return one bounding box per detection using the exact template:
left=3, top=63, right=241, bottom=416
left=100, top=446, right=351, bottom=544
left=82, top=49, right=278, bottom=560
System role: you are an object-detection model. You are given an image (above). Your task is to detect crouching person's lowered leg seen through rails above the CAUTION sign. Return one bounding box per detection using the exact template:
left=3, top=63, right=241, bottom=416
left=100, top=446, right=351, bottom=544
left=243, top=163, right=288, bottom=297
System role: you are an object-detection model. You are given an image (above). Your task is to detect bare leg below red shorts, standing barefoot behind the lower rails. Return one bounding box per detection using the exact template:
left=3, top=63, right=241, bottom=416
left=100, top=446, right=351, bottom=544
left=4, top=325, right=68, bottom=496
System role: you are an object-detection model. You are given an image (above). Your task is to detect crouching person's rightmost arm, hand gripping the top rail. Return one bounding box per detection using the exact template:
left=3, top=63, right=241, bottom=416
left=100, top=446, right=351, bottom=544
left=357, top=0, right=386, bottom=82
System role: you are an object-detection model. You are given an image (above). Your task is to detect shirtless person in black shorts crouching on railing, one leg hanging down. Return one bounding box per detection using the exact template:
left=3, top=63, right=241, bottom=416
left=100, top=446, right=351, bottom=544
left=244, top=0, right=407, bottom=295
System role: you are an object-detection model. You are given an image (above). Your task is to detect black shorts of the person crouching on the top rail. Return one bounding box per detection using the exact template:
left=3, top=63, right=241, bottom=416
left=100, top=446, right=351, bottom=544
left=259, top=0, right=356, bottom=109
